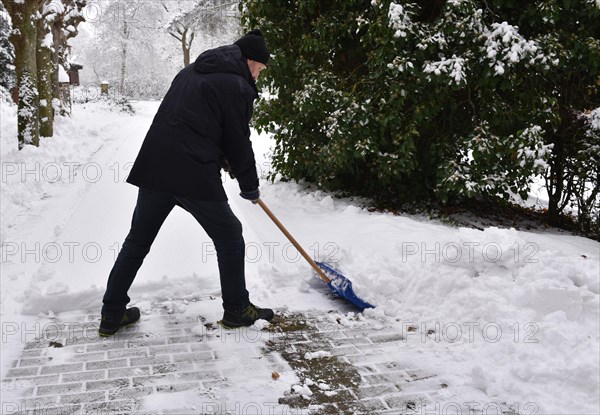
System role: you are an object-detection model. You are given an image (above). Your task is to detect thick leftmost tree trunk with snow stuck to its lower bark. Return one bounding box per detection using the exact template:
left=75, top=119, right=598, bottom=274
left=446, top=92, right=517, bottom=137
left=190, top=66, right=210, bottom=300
left=2, top=0, right=44, bottom=149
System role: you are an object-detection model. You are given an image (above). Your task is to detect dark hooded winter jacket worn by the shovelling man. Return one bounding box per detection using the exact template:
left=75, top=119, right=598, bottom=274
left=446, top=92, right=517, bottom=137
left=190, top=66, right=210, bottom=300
left=127, top=45, right=258, bottom=201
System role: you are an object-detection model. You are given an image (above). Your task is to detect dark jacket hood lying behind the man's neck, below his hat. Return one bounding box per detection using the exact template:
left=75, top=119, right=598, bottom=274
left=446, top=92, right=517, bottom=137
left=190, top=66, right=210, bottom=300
left=194, top=45, right=258, bottom=93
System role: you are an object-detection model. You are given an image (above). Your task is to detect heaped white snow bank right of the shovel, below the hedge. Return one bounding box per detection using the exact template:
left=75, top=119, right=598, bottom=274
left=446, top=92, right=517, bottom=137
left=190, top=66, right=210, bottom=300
left=255, top=183, right=600, bottom=413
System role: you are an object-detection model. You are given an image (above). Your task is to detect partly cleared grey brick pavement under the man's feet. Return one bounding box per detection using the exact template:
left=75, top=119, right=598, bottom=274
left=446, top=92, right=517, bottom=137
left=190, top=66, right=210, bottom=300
left=2, top=303, right=510, bottom=415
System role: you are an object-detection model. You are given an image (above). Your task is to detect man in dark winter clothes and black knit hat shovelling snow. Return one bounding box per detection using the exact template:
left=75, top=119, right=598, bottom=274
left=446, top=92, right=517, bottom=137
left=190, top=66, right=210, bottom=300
left=99, top=30, right=273, bottom=336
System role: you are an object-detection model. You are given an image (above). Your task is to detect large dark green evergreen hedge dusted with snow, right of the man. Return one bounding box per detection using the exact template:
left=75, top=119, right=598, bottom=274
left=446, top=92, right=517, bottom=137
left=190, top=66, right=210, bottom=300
left=242, top=0, right=600, bottom=234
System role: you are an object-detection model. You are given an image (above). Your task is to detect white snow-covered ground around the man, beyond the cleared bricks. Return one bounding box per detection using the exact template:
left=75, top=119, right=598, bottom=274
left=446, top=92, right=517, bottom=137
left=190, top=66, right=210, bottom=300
left=0, top=102, right=600, bottom=414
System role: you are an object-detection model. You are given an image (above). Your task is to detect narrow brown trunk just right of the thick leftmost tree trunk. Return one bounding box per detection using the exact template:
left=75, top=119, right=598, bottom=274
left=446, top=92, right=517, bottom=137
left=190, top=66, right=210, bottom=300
left=36, top=15, right=55, bottom=137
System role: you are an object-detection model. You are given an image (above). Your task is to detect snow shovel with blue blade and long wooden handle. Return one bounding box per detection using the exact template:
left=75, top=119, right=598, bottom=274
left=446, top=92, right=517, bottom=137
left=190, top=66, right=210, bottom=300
left=256, top=199, right=375, bottom=310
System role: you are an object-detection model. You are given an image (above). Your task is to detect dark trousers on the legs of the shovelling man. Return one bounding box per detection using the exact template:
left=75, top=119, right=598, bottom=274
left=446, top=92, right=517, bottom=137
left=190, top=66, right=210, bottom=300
left=102, top=188, right=250, bottom=321
